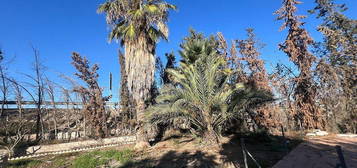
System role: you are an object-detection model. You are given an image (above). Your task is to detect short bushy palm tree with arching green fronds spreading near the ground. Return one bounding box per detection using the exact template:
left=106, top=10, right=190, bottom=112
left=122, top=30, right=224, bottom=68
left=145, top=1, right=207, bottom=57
left=146, top=33, right=271, bottom=143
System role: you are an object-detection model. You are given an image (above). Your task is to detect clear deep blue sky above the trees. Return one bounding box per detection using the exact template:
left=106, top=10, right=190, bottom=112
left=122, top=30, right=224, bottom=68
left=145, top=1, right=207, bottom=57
left=0, top=0, right=357, bottom=100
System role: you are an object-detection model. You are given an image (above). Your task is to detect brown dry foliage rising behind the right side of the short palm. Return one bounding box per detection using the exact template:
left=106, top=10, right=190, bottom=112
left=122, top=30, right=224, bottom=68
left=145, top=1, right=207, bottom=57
left=217, top=29, right=279, bottom=129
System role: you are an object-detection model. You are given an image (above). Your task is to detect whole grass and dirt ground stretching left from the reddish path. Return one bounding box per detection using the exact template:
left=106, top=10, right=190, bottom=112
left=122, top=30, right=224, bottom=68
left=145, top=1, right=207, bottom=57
left=2, top=132, right=302, bottom=168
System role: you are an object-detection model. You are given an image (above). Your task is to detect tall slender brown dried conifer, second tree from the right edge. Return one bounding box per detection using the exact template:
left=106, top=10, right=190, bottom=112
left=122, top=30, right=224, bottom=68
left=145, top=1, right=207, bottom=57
left=276, top=0, right=325, bottom=129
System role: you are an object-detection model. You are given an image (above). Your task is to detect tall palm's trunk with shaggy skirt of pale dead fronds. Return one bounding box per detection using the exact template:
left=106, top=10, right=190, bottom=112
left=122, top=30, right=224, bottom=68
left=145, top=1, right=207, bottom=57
left=125, top=35, right=155, bottom=142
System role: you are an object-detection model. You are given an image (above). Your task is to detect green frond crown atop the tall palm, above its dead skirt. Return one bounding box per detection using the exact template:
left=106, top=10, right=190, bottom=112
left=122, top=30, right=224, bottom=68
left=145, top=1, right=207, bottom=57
left=97, top=0, right=176, bottom=43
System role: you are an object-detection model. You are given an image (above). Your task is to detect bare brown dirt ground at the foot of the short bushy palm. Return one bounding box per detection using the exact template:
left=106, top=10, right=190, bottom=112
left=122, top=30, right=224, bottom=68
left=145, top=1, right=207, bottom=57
left=123, top=133, right=299, bottom=168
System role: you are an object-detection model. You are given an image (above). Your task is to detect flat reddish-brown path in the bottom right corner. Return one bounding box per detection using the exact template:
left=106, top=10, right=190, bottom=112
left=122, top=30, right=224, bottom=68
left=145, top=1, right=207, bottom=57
left=273, top=135, right=357, bottom=168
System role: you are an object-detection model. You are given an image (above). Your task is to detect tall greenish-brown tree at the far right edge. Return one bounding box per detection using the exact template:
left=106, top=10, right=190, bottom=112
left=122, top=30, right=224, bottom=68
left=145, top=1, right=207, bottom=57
left=310, top=0, right=357, bottom=132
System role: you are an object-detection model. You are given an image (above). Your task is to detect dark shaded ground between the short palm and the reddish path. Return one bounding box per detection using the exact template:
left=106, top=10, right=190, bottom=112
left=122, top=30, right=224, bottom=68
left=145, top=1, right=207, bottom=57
left=220, top=133, right=302, bottom=168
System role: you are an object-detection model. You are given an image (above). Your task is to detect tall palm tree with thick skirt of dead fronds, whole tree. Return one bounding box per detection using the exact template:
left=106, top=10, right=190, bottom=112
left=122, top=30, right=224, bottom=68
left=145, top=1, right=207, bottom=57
left=98, top=0, right=176, bottom=144
